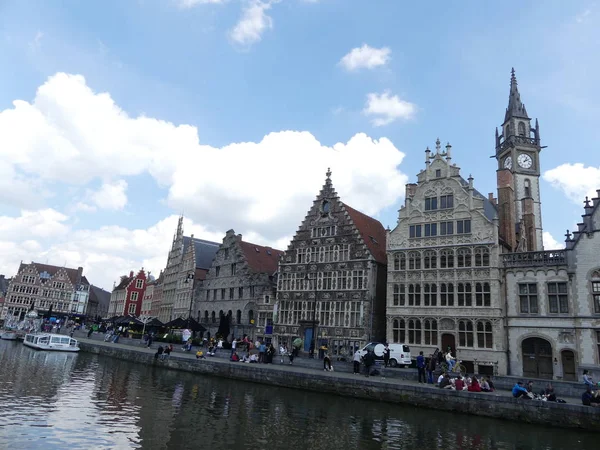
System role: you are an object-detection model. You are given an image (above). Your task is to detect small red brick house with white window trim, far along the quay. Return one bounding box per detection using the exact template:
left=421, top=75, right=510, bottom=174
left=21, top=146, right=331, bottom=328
left=108, top=267, right=148, bottom=317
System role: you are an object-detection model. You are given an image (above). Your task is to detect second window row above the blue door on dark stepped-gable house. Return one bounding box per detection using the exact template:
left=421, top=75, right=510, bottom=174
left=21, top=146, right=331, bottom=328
left=278, top=270, right=367, bottom=291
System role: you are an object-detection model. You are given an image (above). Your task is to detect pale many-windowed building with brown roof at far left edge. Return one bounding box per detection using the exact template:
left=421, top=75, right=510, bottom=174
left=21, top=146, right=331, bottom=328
left=2, top=262, right=90, bottom=319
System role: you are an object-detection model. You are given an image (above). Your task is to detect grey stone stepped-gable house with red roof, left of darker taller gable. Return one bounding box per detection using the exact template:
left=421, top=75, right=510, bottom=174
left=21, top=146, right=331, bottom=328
left=194, top=230, right=283, bottom=340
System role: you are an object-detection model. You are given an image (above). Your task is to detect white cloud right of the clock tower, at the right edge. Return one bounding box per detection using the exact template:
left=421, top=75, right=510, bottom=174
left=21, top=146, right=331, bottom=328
left=544, top=163, right=600, bottom=205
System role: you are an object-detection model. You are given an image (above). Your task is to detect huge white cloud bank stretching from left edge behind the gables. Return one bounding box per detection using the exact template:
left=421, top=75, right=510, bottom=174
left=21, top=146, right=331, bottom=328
left=0, top=73, right=408, bottom=288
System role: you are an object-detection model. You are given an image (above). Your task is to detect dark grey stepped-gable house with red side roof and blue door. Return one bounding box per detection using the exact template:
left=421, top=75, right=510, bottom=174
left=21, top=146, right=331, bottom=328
left=275, top=171, right=386, bottom=356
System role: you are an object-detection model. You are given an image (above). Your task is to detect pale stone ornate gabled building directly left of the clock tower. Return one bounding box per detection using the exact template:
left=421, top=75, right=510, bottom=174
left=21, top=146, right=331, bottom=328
left=387, top=139, right=506, bottom=374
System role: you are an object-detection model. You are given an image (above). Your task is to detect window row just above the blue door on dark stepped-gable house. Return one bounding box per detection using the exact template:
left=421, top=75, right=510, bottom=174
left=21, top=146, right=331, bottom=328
left=277, top=300, right=363, bottom=327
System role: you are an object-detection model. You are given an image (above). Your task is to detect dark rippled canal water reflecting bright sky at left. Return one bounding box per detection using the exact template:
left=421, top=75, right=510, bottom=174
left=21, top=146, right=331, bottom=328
left=0, top=341, right=600, bottom=450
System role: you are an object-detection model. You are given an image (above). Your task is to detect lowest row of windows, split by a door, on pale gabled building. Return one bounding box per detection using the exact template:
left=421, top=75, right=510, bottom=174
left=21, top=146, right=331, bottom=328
left=392, top=319, right=494, bottom=348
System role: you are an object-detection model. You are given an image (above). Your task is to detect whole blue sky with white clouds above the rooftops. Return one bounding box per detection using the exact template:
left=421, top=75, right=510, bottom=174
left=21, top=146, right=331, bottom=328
left=0, top=0, right=600, bottom=289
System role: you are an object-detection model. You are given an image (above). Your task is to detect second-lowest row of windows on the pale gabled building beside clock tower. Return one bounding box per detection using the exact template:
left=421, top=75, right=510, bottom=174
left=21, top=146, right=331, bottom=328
left=392, top=283, right=492, bottom=307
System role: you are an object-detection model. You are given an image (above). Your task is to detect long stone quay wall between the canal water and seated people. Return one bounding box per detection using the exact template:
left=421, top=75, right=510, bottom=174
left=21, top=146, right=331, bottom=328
left=79, top=342, right=600, bottom=431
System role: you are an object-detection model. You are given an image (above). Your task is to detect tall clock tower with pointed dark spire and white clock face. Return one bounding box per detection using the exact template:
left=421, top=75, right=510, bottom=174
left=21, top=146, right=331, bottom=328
left=494, top=69, right=544, bottom=252
